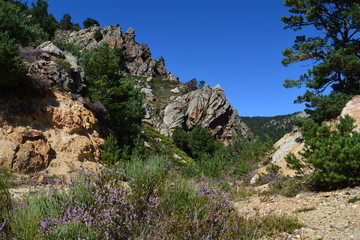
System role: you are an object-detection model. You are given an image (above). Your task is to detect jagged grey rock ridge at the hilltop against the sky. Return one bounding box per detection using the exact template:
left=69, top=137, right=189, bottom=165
left=59, top=25, right=178, bottom=81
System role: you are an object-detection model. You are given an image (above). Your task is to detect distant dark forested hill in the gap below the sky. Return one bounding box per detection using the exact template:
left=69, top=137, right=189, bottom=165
left=241, top=113, right=297, bottom=142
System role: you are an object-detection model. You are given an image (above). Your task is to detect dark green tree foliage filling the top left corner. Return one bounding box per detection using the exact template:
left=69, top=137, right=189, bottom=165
left=0, top=1, right=48, bottom=46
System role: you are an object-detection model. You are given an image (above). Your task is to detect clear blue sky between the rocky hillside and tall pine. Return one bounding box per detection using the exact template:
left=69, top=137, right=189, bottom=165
left=30, top=0, right=320, bottom=116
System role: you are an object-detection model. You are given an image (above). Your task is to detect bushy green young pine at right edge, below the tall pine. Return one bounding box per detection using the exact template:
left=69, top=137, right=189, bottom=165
left=285, top=115, right=360, bottom=188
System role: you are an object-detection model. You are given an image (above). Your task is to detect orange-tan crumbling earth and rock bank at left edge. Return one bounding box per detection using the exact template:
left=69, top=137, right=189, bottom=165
left=0, top=90, right=103, bottom=175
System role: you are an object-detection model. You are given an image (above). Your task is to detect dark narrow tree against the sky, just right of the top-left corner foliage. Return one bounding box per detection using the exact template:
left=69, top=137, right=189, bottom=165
left=30, top=0, right=59, bottom=39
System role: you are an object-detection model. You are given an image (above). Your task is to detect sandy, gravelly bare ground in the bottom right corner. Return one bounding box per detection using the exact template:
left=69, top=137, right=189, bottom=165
left=235, top=187, right=360, bottom=240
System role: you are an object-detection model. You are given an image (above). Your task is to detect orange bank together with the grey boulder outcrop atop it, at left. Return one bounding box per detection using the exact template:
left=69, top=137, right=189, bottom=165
left=0, top=46, right=103, bottom=175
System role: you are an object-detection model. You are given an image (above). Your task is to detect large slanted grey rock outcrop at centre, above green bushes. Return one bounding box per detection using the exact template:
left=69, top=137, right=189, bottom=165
left=145, top=85, right=251, bottom=144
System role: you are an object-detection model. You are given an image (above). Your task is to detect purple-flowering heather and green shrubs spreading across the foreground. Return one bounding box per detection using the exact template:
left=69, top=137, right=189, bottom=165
left=0, top=156, right=299, bottom=239
